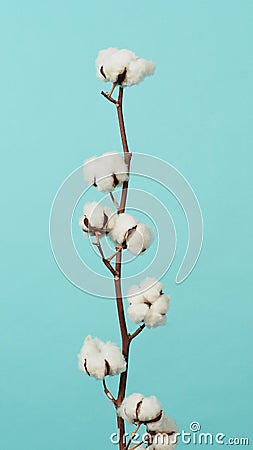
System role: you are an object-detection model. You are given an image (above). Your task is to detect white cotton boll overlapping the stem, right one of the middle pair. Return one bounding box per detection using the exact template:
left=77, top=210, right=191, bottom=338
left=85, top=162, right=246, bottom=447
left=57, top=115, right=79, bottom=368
left=110, top=213, right=153, bottom=255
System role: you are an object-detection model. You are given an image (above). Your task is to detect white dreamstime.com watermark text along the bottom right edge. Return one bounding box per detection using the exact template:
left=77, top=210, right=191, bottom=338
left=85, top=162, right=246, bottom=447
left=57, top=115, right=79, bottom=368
left=110, top=421, right=250, bottom=448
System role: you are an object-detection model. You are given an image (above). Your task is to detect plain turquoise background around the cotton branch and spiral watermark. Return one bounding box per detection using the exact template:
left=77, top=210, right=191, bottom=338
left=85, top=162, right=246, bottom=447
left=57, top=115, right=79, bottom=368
left=0, top=0, right=253, bottom=450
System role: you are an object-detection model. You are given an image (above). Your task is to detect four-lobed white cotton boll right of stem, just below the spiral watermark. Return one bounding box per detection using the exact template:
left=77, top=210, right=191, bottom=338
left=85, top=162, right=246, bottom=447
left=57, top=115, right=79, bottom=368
left=127, top=278, right=170, bottom=328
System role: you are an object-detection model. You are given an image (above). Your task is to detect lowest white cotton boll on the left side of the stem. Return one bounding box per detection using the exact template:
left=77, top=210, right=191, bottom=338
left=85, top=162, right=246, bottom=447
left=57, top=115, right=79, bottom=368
left=78, top=336, right=126, bottom=380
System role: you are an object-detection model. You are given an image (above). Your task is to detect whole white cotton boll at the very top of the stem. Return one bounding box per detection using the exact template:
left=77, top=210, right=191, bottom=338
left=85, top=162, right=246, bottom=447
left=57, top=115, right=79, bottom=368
left=96, top=47, right=155, bottom=86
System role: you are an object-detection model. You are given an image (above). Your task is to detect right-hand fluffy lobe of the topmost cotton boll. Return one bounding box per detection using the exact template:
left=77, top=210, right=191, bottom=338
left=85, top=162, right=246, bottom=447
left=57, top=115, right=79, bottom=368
left=123, top=58, right=155, bottom=86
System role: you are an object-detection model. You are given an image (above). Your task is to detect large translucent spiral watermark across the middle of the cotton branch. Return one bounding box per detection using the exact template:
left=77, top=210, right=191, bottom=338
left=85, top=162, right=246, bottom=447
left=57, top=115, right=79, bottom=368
left=50, top=153, right=203, bottom=298
